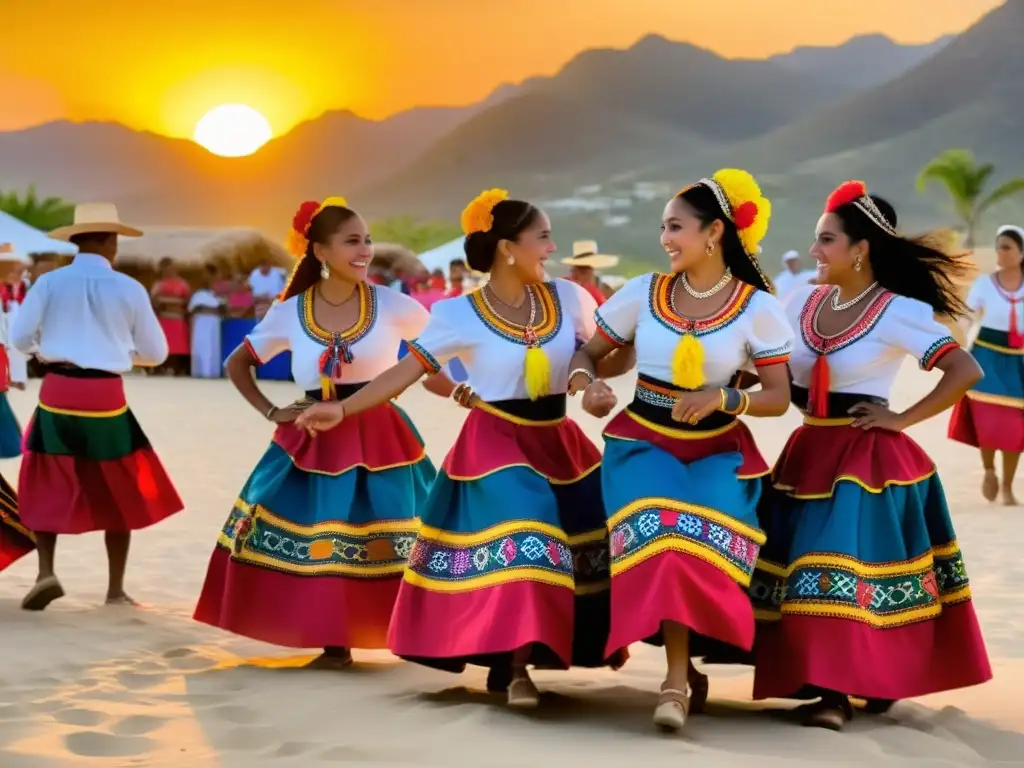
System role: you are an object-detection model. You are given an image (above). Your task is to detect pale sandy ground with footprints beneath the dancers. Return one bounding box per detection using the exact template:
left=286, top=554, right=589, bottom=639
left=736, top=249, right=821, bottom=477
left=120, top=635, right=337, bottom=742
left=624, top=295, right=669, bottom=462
left=0, top=365, right=1024, bottom=768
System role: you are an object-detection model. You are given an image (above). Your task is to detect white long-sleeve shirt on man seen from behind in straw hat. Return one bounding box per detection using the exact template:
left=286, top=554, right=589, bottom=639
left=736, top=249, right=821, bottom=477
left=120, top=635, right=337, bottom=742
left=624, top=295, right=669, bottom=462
left=10, top=253, right=167, bottom=374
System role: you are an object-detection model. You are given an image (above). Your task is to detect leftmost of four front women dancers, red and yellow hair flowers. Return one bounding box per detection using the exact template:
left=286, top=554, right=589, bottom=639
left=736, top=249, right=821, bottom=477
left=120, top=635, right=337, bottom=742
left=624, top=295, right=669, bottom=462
left=195, top=198, right=438, bottom=667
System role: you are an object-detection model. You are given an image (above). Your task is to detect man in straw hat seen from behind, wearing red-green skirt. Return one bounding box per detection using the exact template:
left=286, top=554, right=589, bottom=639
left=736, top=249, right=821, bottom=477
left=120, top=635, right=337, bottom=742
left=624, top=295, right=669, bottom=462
left=10, top=203, right=183, bottom=610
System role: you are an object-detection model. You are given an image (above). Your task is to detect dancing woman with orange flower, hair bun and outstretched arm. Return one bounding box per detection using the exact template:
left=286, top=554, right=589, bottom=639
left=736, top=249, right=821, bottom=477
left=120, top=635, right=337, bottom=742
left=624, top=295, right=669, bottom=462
left=298, top=189, right=631, bottom=707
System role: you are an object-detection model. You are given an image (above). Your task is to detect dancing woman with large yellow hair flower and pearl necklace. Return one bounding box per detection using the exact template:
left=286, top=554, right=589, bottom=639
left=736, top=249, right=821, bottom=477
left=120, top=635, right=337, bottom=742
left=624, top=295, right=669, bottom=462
left=569, top=170, right=794, bottom=730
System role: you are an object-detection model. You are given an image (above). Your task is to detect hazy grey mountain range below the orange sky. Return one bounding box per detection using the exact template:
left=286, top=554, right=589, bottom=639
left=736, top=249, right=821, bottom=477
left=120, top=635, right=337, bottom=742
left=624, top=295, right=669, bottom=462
left=0, top=0, right=1024, bottom=258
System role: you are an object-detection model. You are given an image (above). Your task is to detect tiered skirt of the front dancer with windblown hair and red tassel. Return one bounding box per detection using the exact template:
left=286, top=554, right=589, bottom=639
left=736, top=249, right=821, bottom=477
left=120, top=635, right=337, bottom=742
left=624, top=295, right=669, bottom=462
left=752, top=389, right=992, bottom=700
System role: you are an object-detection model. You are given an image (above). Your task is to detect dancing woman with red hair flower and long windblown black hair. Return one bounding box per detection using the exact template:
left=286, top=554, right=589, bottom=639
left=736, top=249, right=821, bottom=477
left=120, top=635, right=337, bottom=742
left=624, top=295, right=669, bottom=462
left=752, top=181, right=991, bottom=730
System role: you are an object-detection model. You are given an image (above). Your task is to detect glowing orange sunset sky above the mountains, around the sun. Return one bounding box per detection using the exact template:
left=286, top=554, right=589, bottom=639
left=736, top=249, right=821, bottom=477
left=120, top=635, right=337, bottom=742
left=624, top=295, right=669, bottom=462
left=0, top=0, right=1001, bottom=136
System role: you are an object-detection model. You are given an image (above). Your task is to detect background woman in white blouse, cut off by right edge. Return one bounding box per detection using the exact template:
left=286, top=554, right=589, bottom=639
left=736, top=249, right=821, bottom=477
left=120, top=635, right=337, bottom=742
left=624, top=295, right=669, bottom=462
left=949, top=226, right=1024, bottom=506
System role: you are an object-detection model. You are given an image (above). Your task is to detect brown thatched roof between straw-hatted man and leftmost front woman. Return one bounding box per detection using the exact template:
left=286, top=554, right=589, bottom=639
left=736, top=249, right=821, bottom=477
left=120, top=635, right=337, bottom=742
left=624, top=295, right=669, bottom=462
left=117, top=227, right=295, bottom=288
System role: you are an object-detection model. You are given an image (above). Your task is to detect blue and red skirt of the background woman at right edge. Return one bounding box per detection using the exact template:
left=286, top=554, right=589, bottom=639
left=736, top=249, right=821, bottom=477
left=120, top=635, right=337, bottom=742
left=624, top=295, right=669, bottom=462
left=949, top=328, right=1024, bottom=454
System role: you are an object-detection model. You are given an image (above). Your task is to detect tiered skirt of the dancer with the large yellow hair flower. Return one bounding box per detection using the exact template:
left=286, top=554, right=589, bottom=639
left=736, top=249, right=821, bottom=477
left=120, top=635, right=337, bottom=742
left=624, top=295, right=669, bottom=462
left=601, top=376, right=768, bottom=655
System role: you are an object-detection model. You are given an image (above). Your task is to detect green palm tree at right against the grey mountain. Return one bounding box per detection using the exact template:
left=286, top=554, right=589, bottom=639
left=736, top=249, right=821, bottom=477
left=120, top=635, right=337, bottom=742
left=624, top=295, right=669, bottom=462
left=918, top=150, right=1024, bottom=248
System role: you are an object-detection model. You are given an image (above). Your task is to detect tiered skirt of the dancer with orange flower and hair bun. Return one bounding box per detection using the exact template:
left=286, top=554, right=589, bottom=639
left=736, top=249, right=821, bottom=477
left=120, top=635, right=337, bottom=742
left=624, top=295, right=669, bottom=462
left=388, top=394, right=608, bottom=672
